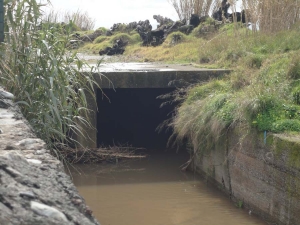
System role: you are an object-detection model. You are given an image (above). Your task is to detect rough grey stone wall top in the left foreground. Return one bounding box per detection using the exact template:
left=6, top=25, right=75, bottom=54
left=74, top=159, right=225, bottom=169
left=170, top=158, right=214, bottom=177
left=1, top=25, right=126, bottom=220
left=0, top=90, right=99, bottom=225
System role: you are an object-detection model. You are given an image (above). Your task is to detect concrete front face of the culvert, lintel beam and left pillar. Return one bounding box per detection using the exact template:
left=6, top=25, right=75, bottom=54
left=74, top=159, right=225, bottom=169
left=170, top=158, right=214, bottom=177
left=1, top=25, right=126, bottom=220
left=77, top=69, right=230, bottom=148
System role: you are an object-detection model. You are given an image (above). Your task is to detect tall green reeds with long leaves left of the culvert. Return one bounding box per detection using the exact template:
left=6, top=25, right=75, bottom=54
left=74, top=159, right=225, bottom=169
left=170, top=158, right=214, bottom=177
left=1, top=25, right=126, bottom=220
left=0, top=0, right=99, bottom=154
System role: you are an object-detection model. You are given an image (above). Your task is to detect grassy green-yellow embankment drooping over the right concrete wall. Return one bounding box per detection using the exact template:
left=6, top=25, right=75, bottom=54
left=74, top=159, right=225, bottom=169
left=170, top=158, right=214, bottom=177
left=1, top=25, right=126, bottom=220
left=78, top=21, right=300, bottom=155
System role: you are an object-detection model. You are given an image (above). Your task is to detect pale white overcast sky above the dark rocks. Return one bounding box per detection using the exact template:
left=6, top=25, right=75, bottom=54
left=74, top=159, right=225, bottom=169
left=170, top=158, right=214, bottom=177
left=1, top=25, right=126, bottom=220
left=43, top=0, right=178, bottom=29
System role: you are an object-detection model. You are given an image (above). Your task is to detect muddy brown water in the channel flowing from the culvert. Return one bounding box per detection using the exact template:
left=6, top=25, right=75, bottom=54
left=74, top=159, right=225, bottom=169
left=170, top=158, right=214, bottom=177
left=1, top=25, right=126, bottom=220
left=72, top=150, right=266, bottom=225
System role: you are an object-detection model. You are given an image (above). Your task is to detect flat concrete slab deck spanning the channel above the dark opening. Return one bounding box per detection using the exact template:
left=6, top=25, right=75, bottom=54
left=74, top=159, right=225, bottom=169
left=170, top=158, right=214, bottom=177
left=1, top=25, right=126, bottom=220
left=86, top=63, right=230, bottom=88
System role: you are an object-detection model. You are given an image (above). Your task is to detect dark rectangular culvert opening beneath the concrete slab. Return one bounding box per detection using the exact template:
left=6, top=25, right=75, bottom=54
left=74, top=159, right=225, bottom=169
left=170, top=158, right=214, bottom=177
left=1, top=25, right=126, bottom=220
left=97, top=88, right=175, bottom=149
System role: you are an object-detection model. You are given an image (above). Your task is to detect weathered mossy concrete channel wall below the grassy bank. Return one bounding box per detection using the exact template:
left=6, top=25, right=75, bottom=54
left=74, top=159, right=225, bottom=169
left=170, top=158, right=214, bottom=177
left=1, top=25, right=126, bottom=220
left=193, top=129, right=300, bottom=225
